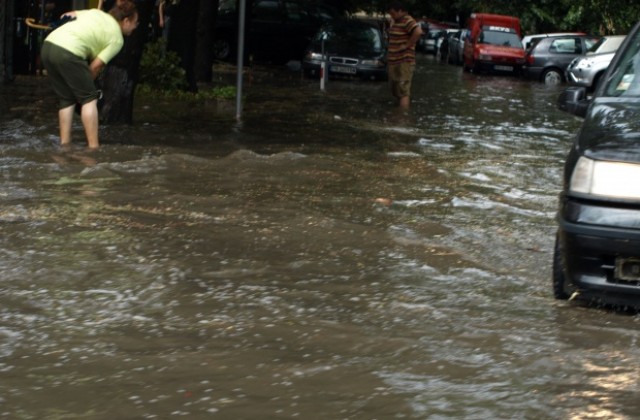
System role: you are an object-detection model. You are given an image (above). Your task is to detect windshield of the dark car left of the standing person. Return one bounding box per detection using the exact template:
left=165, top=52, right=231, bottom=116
left=316, top=26, right=383, bottom=52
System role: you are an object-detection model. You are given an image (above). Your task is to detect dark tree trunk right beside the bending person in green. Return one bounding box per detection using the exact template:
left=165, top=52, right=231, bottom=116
left=98, top=0, right=155, bottom=124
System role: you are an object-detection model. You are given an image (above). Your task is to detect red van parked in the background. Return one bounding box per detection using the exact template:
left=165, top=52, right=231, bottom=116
left=463, top=13, right=525, bottom=74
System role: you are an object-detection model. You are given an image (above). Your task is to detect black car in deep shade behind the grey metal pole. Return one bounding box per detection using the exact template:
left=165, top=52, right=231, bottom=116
left=213, top=0, right=338, bottom=63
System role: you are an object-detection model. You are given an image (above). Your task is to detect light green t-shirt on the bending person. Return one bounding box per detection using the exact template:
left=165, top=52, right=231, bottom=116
left=45, top=9, right=124, bottom=64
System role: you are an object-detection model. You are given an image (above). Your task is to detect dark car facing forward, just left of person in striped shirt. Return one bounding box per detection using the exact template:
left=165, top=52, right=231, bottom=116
left=302, top=20, right=387, bottom=80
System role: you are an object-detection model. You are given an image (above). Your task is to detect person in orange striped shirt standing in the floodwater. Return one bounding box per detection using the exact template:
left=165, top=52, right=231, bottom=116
left=387, top=1, right=422, bottom=108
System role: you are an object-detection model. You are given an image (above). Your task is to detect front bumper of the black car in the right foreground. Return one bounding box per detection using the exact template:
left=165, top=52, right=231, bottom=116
left=558, top=198, right=640, bottom=307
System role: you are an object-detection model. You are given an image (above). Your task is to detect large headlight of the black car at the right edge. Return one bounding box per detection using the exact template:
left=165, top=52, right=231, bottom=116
left=569, top=156, right=640, bottom=200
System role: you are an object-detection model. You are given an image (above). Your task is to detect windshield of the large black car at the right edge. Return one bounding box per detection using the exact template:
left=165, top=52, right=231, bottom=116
left=604, top=31, right=640, bottom=98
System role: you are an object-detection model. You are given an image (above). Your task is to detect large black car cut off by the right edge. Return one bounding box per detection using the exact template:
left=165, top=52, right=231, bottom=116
left=553, top=23, right=640, bottom=309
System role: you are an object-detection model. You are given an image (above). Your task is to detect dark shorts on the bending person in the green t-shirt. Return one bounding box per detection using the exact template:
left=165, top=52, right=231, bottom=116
left=40, top=42, right=99, bottom=109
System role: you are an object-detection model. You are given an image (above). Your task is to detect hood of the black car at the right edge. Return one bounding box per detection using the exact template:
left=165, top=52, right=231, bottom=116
left=577, top=98, right=640, bottom=163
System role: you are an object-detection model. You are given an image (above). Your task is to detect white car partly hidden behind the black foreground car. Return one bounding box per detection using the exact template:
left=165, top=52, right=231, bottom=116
left=565, top=35, right=625, bottom=91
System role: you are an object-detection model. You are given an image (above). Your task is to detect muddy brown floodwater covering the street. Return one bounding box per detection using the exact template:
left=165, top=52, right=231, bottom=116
left=0, top=56, right=640, bottom=420
